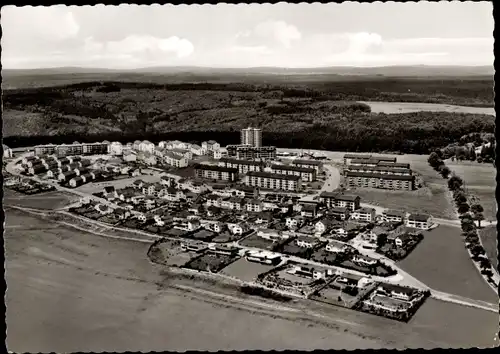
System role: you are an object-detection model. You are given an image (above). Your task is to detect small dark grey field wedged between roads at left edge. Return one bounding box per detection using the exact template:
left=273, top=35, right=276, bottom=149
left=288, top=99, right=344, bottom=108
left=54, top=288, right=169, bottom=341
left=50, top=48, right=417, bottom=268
left=4, top=188, right=79, bottom=210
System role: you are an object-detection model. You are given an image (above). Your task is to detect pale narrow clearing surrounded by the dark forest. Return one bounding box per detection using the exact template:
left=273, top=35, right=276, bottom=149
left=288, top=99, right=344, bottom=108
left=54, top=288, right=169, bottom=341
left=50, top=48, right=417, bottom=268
left=360, top=101, right=495, bottom=116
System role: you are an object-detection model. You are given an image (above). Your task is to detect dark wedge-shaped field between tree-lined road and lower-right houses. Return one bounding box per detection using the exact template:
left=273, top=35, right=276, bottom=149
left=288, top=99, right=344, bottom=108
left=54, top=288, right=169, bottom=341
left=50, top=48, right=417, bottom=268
left=398, top=225, right=498, bottom=303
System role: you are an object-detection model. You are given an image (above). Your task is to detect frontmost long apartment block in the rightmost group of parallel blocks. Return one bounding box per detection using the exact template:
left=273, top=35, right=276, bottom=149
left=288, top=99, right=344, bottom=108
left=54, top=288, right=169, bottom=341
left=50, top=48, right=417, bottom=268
left=345, top=171, right=415, bottom=190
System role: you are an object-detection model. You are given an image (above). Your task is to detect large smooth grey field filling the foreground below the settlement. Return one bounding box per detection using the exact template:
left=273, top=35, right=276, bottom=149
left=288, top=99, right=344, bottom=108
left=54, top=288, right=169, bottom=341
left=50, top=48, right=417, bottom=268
left=5, top=210, right=498, bottom=352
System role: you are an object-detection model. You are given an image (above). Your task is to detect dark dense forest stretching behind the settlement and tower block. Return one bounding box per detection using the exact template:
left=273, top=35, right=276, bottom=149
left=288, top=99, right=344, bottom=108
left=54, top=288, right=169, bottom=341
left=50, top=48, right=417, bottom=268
left=3, top=79, right=495, bottom=154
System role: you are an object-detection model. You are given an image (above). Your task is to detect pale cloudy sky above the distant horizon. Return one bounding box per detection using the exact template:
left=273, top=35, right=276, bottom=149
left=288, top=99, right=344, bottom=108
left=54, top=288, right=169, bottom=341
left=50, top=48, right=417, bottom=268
left=1, top=1, right=494, bottom=69
